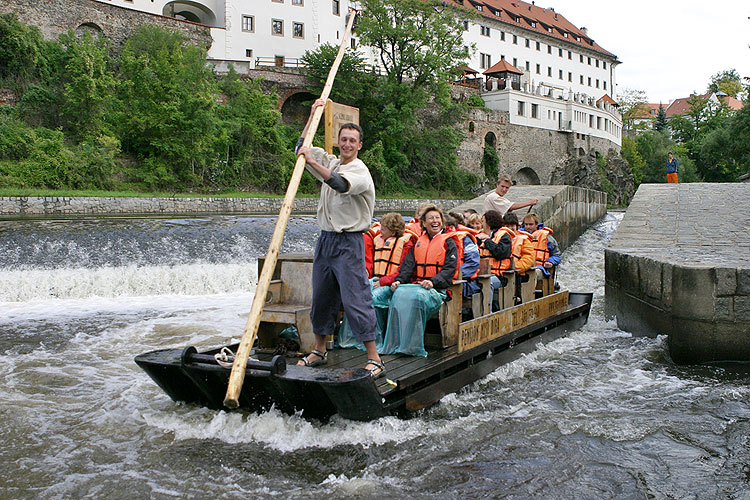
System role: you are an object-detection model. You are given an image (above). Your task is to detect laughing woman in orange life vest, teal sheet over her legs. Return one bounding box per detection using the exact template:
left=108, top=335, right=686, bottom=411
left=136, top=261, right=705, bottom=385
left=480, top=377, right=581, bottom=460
left=378, top=205, right=458, bottom=356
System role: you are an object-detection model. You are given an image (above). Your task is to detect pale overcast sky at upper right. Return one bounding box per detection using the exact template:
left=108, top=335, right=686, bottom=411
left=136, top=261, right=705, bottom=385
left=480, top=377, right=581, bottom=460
left=548, top=0, right=750, bottom=104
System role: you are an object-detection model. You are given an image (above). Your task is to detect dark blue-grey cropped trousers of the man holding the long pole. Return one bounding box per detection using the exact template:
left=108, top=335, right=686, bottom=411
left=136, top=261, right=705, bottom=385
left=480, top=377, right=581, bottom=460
left=310, top=231, right=377, bottom=342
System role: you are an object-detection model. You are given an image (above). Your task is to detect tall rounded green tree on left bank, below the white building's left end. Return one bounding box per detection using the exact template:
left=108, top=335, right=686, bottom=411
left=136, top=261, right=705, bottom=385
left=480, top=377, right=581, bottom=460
left=118, top=25, right=219, bottom=188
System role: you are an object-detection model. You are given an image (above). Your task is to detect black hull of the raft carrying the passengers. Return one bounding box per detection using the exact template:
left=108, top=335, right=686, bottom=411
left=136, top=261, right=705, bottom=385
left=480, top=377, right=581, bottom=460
left=135, top=293, right=592, bottom=421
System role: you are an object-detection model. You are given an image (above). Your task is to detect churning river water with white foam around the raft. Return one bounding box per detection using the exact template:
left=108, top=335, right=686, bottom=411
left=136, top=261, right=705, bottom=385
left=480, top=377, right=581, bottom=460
left=0, top=214, right=750, bottom=500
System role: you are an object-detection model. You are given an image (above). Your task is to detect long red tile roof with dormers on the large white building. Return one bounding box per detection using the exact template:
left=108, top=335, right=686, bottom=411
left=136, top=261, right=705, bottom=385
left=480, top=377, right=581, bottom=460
left=444, top=0, right=619, bottom=62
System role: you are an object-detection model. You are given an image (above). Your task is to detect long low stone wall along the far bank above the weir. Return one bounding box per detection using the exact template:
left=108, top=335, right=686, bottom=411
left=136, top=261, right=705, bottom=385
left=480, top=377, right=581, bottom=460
left=0, top=196, right=468, bottom=219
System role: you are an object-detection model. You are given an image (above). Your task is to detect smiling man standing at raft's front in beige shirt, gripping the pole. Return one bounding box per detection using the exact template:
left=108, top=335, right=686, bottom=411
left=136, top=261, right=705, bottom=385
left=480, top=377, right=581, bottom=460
left=297, top=99, right=385, bottom=377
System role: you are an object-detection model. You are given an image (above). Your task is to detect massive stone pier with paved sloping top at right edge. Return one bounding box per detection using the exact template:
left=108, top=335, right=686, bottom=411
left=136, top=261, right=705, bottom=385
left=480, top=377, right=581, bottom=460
left=605, top=184, right=750, bottom=363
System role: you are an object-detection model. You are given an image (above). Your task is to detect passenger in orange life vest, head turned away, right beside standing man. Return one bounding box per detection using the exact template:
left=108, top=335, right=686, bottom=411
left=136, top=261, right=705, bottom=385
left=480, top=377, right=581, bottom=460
left=336, top=212, right=417, bottom=350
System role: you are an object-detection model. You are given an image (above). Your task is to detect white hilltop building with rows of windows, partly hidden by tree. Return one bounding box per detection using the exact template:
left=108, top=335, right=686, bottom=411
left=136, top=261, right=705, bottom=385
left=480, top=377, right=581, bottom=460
left=97, top=0, right=622, bottom=145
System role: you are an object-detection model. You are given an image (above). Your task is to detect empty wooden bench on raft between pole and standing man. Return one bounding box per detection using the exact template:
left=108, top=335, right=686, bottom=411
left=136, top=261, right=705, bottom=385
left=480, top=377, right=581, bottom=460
left=258, top=254, right=315, bottom=351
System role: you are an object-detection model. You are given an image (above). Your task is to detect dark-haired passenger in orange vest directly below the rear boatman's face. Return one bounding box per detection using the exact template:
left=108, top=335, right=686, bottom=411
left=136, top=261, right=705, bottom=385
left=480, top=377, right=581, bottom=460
left=477, top=210, right=513, bottom=311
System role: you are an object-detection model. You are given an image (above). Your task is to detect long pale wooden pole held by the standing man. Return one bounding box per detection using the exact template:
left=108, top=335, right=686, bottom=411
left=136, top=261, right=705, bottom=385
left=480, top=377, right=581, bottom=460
left=224, top=10, right=356, bottom=408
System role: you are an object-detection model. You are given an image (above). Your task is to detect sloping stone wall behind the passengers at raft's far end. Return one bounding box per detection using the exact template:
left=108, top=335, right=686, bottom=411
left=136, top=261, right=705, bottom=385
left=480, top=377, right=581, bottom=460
left=456, top=186, right=607, bottom=250
